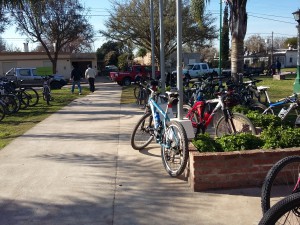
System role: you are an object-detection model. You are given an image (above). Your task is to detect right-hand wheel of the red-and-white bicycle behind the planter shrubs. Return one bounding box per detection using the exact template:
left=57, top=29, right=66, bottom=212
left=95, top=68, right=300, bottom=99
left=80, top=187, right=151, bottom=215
left=215, top=113, right=256, bottom=137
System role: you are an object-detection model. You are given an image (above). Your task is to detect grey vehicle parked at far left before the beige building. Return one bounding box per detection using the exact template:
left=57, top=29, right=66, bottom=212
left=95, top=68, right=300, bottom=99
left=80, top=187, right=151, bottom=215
left=4, top=68, right=67, bottom=89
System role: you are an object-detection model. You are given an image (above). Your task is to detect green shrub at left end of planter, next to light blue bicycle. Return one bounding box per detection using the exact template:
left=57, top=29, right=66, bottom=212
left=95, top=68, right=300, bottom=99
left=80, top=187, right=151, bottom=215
left=192, top=133, right=222, bottom=152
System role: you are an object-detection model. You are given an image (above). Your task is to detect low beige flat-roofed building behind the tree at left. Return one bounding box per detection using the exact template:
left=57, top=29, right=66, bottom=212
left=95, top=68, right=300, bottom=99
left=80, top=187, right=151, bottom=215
left=0, top=52, right=97, bottom=79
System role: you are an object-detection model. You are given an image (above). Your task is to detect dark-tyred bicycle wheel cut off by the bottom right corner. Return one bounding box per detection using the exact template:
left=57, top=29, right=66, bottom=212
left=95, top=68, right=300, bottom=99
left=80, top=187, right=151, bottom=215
left=259, top=193, right=300, bottom=225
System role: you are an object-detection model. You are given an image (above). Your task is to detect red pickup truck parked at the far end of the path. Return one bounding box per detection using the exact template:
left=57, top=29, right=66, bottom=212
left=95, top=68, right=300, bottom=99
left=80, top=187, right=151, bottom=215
left=109, top=65, right=160, bottom=86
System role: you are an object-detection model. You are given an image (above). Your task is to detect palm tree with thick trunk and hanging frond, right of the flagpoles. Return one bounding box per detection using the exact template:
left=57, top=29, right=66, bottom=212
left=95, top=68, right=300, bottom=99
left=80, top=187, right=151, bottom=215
left=191, top=0, right=247, bottom=82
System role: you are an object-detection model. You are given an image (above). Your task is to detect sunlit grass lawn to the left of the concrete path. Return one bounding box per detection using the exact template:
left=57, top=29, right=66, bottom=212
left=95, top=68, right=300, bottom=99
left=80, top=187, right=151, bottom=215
left=0, top=88, right=89, bottom=149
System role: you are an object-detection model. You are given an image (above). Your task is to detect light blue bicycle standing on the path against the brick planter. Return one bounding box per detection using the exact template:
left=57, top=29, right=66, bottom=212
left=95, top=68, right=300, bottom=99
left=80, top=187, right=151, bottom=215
left=130, top=81, right=189, bottom=177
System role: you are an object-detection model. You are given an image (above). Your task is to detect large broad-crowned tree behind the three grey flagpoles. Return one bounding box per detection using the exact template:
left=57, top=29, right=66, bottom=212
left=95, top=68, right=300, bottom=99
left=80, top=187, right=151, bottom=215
left=99, top=0, right=216, bottom=66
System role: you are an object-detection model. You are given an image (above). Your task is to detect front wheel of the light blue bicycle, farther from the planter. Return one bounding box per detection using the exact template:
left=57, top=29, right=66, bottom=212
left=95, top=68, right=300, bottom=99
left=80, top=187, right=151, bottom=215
left=130, top=112, right=154, bottom=150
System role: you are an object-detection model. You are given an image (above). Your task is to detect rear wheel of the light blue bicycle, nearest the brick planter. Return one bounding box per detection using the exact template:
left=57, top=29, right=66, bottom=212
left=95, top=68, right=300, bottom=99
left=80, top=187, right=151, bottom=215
left=161, top=121, right=189, bottom=177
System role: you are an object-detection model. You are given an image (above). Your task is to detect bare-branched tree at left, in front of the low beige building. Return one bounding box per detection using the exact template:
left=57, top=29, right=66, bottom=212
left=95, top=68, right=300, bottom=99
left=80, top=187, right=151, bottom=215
left=11, top=0, right=94, bottom=73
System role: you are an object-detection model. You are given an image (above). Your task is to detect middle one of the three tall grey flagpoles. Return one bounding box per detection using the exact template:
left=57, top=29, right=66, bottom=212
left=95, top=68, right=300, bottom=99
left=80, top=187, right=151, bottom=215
left=159, top=0, right=166, bottom=93
